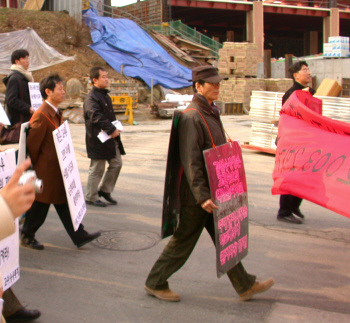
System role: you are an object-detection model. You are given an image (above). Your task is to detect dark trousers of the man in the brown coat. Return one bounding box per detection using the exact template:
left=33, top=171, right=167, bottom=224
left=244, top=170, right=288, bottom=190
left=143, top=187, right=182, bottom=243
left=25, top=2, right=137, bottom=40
left=22, top=201, right=88, bottom=244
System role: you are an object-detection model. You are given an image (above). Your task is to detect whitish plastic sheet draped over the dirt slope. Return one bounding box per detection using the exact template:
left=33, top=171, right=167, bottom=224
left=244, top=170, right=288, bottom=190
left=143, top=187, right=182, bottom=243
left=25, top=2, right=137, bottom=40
left=0, top=28, right=75, bottom=75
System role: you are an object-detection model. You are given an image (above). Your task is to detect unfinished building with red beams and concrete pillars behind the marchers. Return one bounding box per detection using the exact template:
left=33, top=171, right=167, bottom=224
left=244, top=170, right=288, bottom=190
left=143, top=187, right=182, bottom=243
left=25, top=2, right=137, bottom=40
left=114, top=0, right=350, bottom=57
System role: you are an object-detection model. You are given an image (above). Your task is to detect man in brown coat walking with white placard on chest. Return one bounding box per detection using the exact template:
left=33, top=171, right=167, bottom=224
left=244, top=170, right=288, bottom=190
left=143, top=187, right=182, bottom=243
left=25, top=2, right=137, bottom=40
left=21, top=74, right=101, bottom=250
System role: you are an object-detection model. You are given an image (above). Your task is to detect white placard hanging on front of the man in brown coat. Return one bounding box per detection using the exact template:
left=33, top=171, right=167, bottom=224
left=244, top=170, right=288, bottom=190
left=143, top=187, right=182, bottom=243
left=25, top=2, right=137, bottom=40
left=53, top=121, right=86, bottom=231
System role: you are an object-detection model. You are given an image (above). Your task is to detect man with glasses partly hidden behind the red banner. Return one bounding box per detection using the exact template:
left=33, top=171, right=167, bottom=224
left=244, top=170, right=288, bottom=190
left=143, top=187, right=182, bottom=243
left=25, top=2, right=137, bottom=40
left=277, top=61, right=316, bottom=224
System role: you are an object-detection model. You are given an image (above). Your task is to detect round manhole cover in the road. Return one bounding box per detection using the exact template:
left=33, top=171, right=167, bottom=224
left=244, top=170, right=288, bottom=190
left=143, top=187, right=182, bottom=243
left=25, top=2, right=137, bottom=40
left=93, top=231, right=160, bottom=251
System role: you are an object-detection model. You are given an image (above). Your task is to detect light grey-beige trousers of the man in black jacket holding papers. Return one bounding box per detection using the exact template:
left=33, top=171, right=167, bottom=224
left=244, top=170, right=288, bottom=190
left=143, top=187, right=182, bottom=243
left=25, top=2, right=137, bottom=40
left=85, top=146, right=123, bottom=202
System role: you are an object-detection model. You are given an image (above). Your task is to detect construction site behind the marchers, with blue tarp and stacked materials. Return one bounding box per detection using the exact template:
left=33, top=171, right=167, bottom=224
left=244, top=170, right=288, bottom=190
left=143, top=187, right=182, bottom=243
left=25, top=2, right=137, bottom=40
left=0, top=0, right=350, bottom=152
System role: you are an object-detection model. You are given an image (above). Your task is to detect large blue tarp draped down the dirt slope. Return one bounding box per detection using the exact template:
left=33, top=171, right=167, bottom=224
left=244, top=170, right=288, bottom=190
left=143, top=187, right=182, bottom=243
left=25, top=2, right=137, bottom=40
left=84, top=10, right=192, bottom=89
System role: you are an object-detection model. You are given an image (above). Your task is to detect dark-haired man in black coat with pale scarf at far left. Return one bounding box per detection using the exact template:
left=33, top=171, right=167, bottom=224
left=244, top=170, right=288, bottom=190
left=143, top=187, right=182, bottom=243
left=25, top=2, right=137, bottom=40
left=3, top=49, right=34, bottom=125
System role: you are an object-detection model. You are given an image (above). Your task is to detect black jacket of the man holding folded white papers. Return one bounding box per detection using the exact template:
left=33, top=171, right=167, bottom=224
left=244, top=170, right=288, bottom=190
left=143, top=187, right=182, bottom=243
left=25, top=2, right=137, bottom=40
left=84, top=86, right=125, bottom=160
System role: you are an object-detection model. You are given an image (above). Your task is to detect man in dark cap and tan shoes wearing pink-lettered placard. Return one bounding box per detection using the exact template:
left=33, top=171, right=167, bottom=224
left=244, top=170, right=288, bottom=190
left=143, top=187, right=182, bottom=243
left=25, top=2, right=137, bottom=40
left=145, top=66, right=274, bottom=302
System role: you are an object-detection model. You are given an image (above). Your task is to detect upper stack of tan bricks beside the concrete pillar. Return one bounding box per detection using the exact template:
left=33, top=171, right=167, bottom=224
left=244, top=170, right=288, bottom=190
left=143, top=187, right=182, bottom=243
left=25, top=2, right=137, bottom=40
left=218, top=42, right=258, bottom=77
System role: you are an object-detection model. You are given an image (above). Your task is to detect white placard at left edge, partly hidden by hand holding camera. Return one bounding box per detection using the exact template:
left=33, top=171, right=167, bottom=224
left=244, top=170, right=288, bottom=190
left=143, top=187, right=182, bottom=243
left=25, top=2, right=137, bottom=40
left=0, top=148, right=20, bottom=290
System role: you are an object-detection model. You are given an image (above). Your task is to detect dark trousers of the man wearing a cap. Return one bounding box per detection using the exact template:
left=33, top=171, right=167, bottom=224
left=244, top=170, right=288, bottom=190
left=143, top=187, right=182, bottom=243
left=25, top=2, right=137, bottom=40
left=146, top=206, right=256, bottom=294
